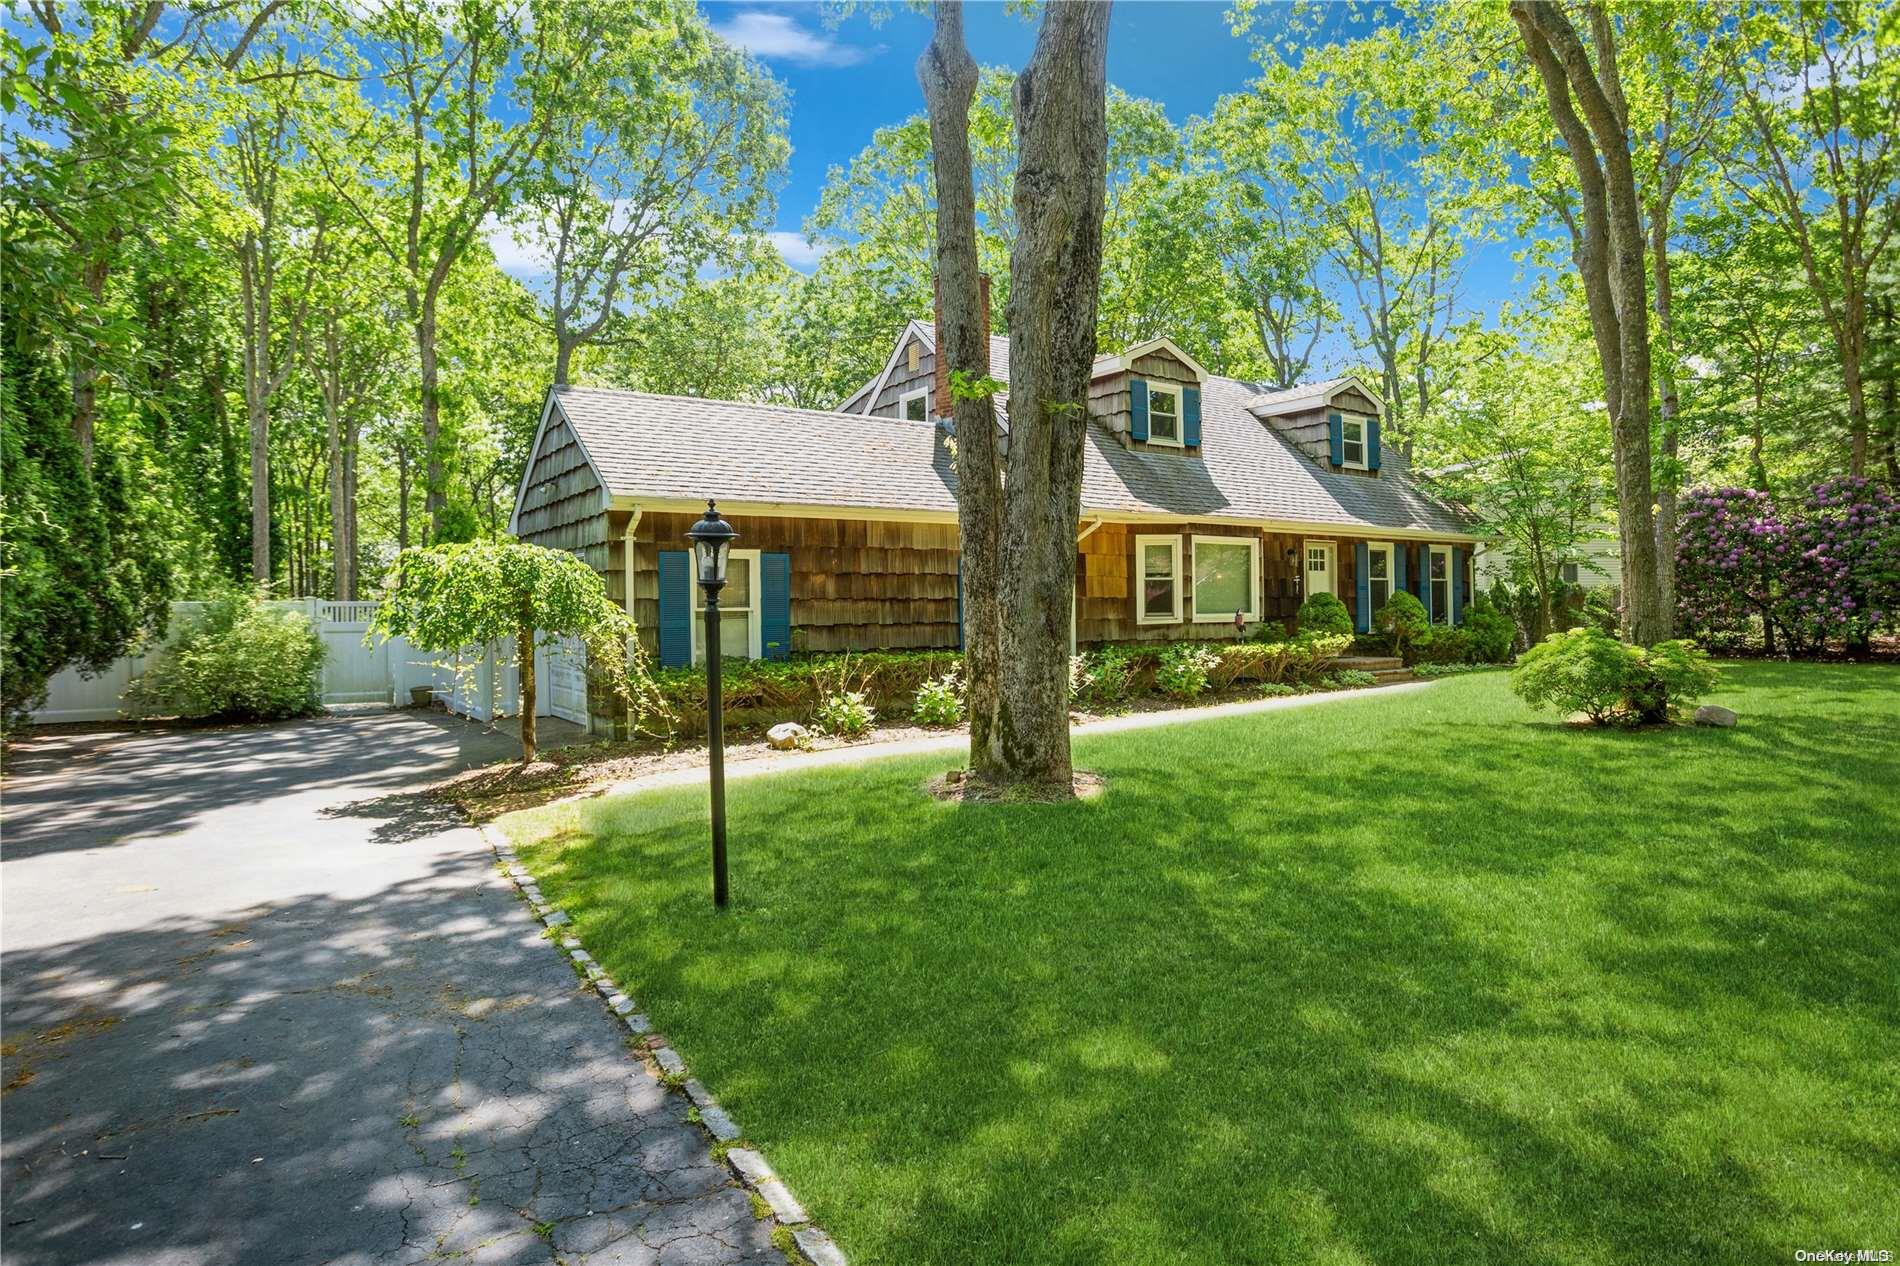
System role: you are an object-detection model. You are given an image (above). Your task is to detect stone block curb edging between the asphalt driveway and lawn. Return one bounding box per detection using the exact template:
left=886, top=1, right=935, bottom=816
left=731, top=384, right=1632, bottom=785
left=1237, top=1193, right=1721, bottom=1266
left=475, top=823, right=846, bottom=1266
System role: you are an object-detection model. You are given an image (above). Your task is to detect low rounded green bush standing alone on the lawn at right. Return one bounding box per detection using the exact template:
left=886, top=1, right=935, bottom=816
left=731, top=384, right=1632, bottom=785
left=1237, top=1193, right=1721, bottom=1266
left=1511, top=625, right=1720, bottom=726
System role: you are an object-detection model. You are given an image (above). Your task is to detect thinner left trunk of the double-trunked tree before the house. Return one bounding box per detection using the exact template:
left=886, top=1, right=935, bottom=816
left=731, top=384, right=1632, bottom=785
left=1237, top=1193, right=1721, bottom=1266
left=918, top=0, right=1009, bottom=779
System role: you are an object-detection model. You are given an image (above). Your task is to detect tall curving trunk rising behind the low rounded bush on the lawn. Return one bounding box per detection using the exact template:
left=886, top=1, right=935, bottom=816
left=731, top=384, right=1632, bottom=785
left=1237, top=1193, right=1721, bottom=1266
left=1511, top=0, right=1672, bottom=644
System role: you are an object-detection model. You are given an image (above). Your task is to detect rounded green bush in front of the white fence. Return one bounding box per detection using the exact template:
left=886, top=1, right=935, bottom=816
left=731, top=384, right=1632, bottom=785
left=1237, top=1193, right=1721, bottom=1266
left=125, top=589, right=323, bottom=720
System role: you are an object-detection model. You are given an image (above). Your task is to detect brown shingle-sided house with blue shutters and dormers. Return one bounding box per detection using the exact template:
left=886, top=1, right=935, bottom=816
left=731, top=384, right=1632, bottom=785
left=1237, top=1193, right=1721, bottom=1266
left=509, top=300, right=1476, bottom=726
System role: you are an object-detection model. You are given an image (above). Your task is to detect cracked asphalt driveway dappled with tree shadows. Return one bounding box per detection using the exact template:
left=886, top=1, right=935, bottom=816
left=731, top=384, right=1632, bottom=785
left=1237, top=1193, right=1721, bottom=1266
left=0, top=713, right=785, bottom=1266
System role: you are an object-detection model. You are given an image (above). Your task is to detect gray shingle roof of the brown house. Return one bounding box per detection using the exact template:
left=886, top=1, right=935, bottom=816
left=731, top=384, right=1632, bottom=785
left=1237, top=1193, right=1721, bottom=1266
left=555, top=370, right=1471, bottom=534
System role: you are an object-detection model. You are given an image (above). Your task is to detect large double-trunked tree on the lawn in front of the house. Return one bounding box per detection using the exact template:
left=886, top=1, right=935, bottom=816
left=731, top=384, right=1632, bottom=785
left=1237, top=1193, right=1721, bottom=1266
left=918, top=0, right=1110, bottom=796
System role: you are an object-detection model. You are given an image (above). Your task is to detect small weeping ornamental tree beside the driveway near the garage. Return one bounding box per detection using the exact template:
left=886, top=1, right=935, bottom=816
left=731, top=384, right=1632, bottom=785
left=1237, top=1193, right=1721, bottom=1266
left=371, top=542, right=654, bottom=764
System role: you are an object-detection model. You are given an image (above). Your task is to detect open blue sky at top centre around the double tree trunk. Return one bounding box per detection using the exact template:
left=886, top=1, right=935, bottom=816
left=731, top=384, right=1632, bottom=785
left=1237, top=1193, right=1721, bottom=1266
left=703, top=0, right=1252, bottom=268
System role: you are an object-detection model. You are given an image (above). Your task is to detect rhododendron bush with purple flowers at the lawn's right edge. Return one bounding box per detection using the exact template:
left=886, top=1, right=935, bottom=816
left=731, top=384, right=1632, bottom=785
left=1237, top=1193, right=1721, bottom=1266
left=1676, top=477, right=1900, bottom=652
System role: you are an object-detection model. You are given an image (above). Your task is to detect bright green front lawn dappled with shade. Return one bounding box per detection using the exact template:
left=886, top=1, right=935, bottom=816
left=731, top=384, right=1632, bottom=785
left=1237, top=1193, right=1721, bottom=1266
left=504, top=663, right=1900, bottom=1266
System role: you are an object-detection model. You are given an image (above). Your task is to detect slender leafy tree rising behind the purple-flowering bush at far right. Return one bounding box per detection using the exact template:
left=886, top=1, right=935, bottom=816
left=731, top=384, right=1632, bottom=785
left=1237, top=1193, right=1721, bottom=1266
left=1727, top=0, right=1900, bottom=475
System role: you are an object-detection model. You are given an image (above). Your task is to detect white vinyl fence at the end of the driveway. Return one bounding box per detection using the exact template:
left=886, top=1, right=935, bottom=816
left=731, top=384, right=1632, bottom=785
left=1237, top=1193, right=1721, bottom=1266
left=32, top=599, right=587, bottom=726
